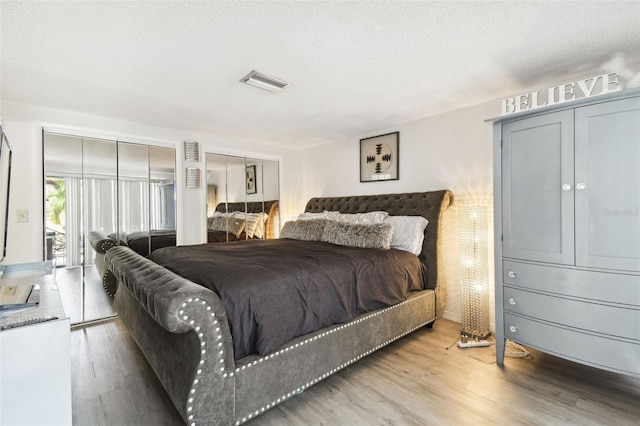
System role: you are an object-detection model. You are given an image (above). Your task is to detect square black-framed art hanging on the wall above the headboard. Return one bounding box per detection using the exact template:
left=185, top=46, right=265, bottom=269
left=360, top=132, right=400, bottom=182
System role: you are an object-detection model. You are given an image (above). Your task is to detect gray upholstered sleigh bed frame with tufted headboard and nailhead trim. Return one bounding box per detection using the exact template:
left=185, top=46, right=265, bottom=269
left=105, top=190, right=453, bottom=425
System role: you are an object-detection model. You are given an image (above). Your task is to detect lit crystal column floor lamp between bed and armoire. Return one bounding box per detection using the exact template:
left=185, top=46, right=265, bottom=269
left=459, top=206, right=491, bottom=339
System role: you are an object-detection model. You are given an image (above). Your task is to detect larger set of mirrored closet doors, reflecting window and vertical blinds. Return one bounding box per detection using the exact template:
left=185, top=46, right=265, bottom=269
left=43, top=132, right=176, bottom=324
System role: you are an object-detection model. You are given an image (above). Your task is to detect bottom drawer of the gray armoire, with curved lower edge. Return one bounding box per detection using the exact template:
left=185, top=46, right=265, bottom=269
left=504, top=313, right=640, bottom=376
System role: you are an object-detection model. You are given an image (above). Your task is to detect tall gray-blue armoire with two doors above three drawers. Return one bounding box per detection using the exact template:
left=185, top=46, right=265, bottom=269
left=494, top=90, right=640, bottom=376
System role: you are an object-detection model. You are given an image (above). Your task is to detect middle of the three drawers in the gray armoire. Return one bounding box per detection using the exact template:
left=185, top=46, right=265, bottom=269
left=503, top=287, right=640, bottom=342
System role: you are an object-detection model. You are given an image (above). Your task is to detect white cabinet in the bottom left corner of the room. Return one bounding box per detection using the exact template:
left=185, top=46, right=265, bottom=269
left=0, top=267, right=71, bottom=426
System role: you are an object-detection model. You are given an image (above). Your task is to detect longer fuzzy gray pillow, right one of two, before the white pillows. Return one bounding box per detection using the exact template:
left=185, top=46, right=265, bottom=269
left=321, top=220, right=393, bottom=250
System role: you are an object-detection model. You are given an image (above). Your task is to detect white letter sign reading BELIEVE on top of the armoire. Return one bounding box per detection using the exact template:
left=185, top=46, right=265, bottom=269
left=500, top=72, right=622, bottom=115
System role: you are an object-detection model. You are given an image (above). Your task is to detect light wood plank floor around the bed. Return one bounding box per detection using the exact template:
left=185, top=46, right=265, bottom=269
left=71, top=320, right=640, bottom=426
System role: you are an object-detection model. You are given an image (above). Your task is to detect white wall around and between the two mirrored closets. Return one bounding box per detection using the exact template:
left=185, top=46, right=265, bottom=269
left=2, top=101, right=281, bottom=264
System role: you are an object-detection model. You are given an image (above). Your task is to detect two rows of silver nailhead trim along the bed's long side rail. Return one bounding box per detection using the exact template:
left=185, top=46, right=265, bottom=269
left=232, top=293, right=435, bottom=426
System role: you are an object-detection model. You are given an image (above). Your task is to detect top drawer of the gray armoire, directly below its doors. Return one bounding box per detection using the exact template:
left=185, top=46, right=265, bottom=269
left=502, top=261, right=640, bottom=306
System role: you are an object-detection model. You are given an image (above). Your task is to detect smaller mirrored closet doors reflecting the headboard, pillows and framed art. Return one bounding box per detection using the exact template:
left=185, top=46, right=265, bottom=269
left=206, top=153, right=280, bottom=243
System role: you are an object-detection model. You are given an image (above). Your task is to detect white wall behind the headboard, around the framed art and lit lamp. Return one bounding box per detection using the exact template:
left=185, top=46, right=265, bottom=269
left=282, top=101, right=500, bottom=324
